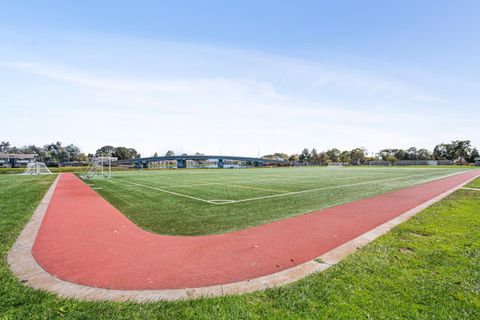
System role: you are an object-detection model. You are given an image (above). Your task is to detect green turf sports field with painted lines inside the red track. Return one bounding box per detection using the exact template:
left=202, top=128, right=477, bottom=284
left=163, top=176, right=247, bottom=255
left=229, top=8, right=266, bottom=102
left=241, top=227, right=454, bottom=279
left=87, top=167, right=472, bottom=235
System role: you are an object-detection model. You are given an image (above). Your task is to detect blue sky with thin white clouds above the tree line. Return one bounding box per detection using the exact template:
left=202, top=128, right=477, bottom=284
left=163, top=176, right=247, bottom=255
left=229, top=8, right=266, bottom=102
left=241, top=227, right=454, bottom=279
left=0, top=0, right=480, bottom=155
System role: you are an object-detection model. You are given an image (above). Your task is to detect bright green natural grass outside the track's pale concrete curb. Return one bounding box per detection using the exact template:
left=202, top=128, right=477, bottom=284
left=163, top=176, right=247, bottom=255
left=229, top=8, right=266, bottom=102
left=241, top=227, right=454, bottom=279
left=0, top=176, right=480, bottom=320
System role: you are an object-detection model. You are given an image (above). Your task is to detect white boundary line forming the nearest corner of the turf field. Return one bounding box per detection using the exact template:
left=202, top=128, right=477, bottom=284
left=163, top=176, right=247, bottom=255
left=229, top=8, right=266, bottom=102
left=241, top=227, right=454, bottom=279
left=116, top=170, right=466, bottom=205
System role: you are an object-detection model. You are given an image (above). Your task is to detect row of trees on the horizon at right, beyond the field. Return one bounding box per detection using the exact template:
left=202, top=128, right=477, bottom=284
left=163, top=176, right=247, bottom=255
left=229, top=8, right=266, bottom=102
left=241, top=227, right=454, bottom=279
left=263, top=140, right=480, bottom=165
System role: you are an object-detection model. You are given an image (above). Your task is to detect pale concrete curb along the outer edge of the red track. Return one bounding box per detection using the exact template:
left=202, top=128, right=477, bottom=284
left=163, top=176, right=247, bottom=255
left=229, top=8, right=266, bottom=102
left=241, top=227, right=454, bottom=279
left=7, top=171, right=480, bottom=302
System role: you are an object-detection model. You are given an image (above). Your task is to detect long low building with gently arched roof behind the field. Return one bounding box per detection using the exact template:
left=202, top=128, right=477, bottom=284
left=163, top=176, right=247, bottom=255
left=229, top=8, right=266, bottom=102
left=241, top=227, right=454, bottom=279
left=117, top=155, right=285, bottom=168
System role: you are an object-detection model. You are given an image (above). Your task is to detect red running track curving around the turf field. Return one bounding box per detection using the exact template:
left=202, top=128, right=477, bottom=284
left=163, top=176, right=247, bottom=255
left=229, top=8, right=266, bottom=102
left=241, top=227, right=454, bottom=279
left=32, top=170, right=479, bottom=290
